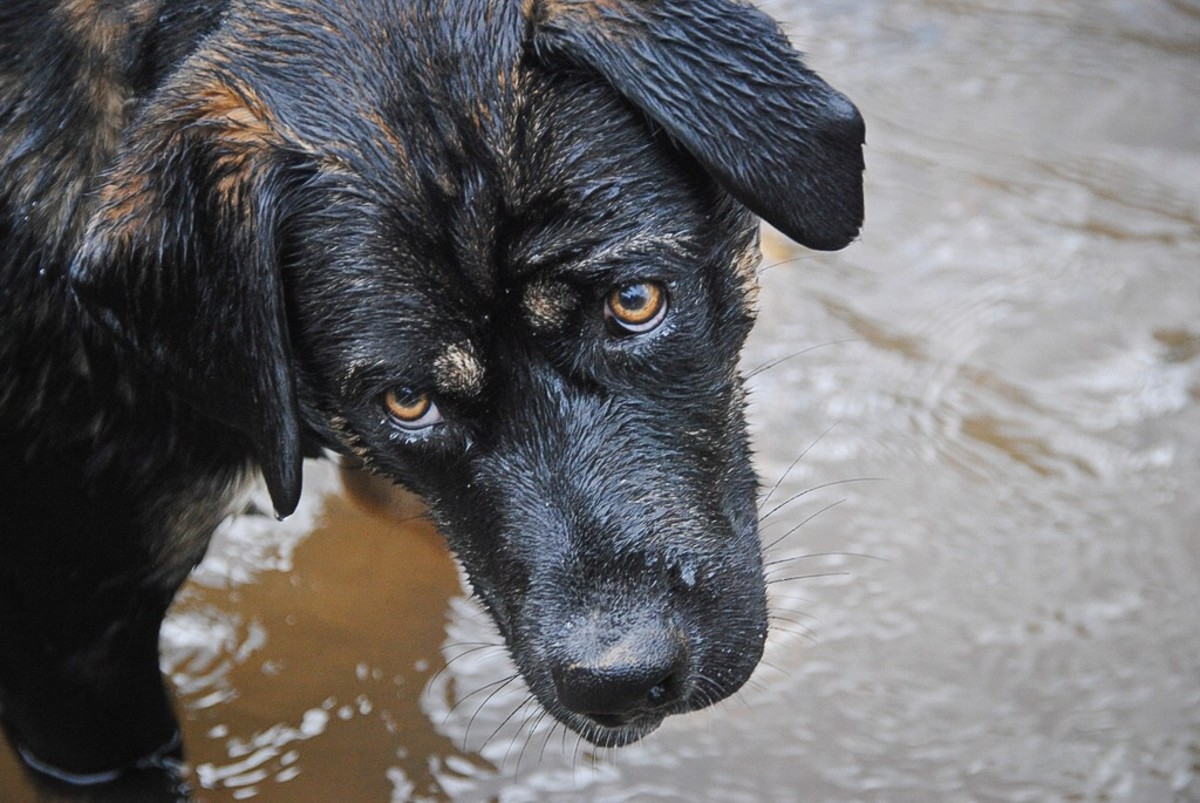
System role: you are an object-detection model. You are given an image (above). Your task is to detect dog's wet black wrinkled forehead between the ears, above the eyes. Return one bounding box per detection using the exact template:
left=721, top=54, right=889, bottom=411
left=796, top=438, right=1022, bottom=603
left=263, top=0, right=752, bottom=408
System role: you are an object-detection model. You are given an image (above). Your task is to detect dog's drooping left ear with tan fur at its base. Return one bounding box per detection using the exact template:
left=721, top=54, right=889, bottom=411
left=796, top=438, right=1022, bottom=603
left=70, top=78, right=302, bottom=516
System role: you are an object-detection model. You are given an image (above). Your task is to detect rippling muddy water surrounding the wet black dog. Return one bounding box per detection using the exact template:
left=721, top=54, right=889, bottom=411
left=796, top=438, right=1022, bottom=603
left=0, top=0, right=1200, bottom=803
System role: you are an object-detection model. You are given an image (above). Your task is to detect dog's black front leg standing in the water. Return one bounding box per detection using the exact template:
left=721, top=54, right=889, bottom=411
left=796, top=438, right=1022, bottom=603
left=0, top=434, right=241, bottom=783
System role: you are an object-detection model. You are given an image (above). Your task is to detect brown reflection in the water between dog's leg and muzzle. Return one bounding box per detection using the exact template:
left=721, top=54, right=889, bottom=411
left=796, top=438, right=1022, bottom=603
left=163, top=467, right=485, bottom=799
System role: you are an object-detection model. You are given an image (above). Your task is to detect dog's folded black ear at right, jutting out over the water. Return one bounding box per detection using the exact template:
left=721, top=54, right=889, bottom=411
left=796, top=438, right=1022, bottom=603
left=532, top=0, right=864, bottom=251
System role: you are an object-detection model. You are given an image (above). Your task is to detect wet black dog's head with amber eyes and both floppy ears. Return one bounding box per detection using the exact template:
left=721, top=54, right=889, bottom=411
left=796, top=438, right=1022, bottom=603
left=72, top=0, right=863, bottom=744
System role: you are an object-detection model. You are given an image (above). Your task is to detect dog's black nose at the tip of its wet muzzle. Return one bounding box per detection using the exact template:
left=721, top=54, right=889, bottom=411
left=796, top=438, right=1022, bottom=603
left=551, top=627, right=688, bottom=727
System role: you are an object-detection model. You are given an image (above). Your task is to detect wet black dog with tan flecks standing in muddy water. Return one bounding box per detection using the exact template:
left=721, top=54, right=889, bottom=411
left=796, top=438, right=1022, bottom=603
left=0, top=0, right=863, bottom=780
